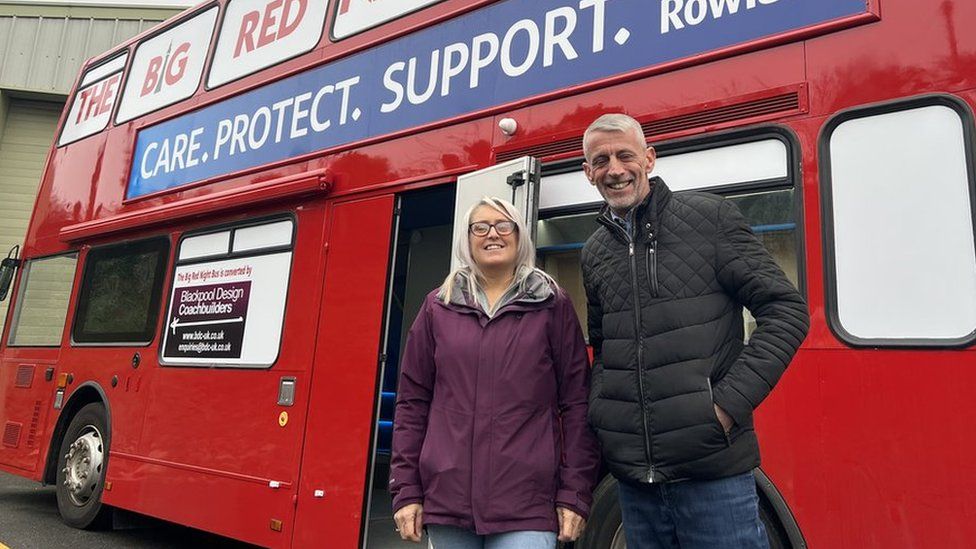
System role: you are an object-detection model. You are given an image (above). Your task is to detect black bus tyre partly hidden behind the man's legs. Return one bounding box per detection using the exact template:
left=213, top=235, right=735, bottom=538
left=575, top=475, right=790, bottom=549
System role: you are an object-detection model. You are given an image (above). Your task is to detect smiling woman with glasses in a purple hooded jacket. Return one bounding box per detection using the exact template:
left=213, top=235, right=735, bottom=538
left=390, top=197, right=599, bottom=549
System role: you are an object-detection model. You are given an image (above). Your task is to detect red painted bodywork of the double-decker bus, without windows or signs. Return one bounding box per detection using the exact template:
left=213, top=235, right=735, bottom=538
left=0, top=0, right=976, bottom=549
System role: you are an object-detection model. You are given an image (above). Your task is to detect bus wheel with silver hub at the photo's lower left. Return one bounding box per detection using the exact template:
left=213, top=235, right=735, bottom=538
left=57, top=403, right=111, bottom=529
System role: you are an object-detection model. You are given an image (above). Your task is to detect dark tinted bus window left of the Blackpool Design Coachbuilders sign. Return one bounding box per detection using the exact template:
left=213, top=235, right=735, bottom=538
left=71, top=238, right=169, bottom=345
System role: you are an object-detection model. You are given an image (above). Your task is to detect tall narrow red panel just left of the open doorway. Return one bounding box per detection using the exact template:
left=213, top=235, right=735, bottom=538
left=292, top=195, right=394, bottom=548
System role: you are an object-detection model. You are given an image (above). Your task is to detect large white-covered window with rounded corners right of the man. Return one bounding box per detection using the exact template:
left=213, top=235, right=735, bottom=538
left=822, top=96, right=976, bottom=345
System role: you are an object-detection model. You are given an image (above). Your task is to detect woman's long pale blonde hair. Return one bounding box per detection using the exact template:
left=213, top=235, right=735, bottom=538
left=437, top=196, right=552, bottom=303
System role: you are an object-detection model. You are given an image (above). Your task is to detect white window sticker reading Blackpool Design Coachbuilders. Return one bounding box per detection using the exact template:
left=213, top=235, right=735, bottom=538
left=162, top=252, right=292, bottom=368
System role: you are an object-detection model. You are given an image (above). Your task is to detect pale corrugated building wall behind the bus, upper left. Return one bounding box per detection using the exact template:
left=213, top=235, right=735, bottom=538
left=0, top=0, right=180, bottom=329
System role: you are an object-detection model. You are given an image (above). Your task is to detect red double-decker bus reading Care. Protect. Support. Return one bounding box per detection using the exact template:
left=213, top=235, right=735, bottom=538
left=0, top=0, right=976, bottom=549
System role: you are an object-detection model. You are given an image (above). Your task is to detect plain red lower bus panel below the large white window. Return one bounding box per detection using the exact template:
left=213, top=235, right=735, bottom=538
left=756, top=349, right=976, bottom=549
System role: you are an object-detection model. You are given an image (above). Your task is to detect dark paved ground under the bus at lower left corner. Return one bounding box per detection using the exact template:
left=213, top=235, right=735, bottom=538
left=0, top=472, right=253, bottom=549
